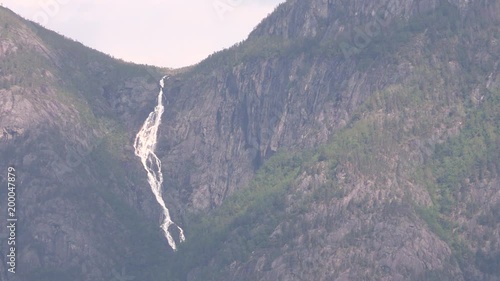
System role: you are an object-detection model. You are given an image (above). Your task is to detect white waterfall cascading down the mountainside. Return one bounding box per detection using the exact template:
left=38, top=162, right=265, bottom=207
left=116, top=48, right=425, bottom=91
left=134, top=76, right=185, bottom=251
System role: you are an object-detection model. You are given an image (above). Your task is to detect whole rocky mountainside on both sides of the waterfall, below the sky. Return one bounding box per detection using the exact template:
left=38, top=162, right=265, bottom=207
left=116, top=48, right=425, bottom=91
left=0, top=0, right=500, bottom=281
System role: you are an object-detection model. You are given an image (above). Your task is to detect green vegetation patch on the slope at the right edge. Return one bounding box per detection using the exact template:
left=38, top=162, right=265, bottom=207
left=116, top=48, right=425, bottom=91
left=420, top=81, right=500, bottom=275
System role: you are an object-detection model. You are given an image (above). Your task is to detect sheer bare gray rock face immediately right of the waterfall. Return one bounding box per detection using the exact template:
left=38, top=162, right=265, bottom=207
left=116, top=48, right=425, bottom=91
left=159, top=57, right=350, bottom=210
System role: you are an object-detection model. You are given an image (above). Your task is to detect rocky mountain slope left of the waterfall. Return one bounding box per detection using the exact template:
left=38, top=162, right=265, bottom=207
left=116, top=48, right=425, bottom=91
left=0, top=8, right=178, bottom=280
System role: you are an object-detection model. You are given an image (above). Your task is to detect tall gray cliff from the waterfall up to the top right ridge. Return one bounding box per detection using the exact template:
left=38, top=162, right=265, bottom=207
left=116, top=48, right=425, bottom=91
left=156, top=1, right=499, bottom=210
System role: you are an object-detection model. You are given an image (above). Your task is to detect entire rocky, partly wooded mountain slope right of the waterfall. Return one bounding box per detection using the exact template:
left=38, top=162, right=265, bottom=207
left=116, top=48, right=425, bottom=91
left=159, top=1, right=500, bottom=280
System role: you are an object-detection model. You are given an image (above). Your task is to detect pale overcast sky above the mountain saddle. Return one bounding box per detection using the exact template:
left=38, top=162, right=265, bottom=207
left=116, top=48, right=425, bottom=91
left=0, top=0, right=285, bottom=67
